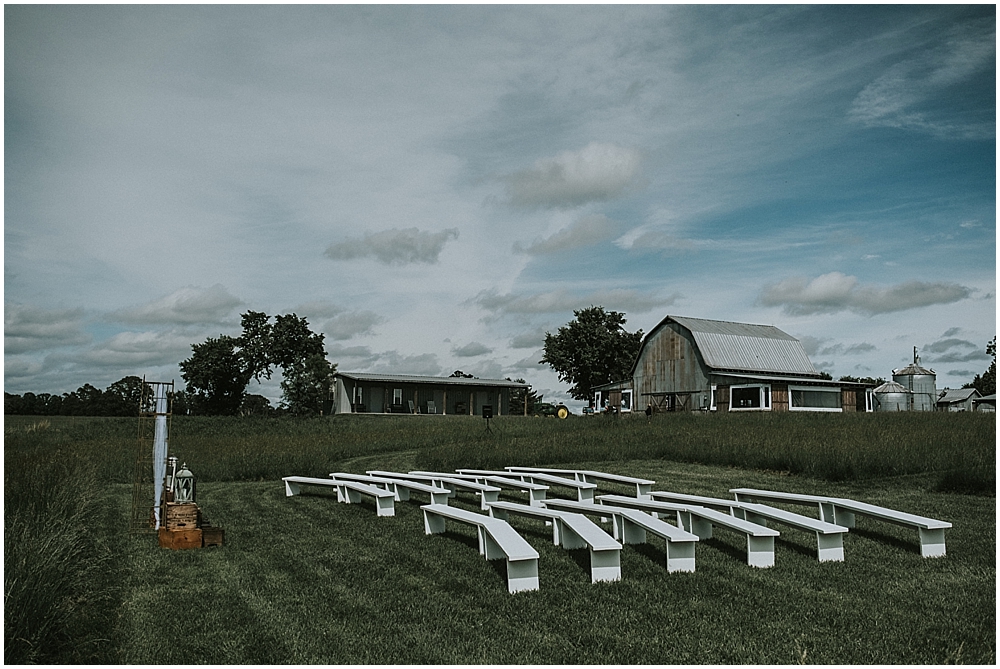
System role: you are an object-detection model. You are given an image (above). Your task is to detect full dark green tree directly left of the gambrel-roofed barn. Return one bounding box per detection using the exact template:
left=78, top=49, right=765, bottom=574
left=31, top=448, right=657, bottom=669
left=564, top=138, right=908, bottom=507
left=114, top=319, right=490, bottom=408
left=539, top=306, right=642, bottom=400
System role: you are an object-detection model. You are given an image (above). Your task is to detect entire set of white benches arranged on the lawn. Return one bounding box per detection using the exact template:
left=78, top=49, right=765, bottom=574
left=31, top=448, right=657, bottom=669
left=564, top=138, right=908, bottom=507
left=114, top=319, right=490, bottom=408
left=283, top=467, right=951, bottom=592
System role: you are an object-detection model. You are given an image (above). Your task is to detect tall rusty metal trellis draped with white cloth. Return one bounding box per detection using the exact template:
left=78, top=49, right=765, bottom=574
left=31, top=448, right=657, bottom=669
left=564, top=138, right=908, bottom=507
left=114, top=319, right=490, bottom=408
left=129, top=377, right=174, bottom=534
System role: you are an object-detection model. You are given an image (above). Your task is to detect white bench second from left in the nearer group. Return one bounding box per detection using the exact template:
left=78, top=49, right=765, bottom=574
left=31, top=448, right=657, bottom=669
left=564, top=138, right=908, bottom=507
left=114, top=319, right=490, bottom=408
left=490, top=502, right=622, bottom=583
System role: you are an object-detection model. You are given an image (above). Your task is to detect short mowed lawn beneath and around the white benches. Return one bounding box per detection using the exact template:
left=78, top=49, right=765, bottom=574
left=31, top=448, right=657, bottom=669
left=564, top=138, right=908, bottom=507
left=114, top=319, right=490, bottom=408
left=111, top=453, right=996, bottom=664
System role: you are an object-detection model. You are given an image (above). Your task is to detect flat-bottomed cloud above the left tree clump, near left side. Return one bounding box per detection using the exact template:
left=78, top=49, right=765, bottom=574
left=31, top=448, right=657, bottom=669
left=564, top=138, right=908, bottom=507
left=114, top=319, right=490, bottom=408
left=109, top=283, right=243, bottom=325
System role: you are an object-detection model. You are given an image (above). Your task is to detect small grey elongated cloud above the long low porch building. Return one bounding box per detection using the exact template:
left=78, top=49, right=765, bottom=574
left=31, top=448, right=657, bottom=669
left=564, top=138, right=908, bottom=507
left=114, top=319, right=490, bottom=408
left=325, top=228, right=458, bottom=265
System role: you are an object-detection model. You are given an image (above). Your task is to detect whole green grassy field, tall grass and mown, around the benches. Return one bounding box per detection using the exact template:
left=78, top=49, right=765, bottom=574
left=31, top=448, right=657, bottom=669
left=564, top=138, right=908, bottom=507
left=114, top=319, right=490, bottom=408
left=4, top=414, right=996, bottom=664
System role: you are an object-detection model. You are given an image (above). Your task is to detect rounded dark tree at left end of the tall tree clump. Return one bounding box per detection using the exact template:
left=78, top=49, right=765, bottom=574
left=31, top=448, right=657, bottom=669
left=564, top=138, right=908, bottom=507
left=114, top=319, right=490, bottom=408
left=180, top=335, right=251, bottom=416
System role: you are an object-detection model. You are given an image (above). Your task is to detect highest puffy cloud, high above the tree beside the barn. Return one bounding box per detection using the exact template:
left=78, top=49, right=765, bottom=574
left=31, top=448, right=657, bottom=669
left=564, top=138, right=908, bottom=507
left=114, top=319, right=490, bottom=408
left=503, top=142, right=642, bottom=209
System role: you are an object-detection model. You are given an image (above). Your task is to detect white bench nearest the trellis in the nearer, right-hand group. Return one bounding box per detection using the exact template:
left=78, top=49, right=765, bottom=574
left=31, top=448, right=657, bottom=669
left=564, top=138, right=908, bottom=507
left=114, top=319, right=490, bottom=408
left=420, top=504, right=538, bottom=593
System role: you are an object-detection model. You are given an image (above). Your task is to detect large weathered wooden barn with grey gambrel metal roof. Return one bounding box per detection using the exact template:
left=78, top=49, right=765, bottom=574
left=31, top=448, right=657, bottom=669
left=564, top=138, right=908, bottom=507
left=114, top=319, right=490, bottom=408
left=594, top=316, right=872, bottom=412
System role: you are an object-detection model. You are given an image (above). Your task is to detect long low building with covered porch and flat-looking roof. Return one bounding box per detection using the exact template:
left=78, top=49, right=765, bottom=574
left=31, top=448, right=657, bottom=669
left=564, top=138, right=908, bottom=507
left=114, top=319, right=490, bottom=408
left=332, top=372, right=528, bottom=416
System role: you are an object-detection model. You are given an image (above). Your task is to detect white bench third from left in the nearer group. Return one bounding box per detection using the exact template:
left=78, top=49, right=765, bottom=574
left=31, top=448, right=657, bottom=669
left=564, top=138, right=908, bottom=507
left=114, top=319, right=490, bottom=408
left=544, top=499, right=698, bottom=572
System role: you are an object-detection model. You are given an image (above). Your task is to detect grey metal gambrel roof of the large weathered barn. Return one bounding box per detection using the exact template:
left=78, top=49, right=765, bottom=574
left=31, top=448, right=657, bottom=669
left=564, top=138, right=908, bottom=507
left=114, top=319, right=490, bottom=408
left=648, top=316, right=819, bottom=377
